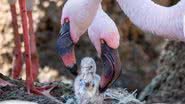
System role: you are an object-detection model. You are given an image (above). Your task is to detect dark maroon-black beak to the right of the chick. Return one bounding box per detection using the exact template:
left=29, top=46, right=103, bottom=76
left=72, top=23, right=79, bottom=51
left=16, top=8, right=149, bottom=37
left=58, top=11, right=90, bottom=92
left=99, top=42, right=121, bottom=92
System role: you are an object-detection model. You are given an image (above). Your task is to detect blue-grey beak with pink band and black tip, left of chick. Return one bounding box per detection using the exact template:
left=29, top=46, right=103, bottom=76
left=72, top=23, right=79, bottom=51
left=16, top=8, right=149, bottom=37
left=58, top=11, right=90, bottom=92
left=56, top=20, right=78, bottom=76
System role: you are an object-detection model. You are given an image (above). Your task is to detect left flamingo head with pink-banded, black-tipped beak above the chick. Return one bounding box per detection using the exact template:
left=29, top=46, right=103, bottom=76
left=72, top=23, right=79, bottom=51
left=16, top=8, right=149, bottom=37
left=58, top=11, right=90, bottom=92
left=56, top=0, right=102, bottom=76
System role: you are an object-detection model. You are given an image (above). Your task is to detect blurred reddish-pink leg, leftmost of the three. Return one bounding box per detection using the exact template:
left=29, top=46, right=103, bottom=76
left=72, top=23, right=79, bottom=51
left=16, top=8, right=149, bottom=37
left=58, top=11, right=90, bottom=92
left=10, top=3, right=22, bottom=79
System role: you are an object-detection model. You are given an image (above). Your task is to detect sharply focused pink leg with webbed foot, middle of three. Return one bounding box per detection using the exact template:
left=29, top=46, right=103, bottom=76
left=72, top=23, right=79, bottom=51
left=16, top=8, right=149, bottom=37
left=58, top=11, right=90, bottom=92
left=19, top=0, right=54, bottom=96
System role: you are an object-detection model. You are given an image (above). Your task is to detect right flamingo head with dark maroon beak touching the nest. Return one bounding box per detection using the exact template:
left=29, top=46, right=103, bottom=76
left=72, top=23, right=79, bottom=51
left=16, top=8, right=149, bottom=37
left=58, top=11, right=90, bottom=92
left=88, top=5, right=121, bottom=92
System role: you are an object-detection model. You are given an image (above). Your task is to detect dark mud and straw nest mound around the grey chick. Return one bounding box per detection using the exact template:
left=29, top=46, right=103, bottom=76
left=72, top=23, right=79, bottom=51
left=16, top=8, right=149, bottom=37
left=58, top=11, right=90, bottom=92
left=0, top=74, right=143, bottom=104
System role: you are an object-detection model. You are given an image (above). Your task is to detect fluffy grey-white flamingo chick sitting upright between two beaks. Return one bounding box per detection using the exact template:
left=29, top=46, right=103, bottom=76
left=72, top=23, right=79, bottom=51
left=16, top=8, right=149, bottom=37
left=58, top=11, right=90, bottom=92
left=74, top=57, right=103, bottom=104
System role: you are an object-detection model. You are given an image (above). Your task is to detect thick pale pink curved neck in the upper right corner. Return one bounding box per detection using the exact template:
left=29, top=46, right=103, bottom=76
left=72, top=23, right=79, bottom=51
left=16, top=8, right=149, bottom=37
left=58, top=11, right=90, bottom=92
left=117, top=0, right=185, bottom=41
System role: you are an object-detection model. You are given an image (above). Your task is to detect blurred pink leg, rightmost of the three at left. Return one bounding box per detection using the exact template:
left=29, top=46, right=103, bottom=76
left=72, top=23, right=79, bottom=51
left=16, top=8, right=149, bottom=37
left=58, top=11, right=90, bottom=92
left=27, top=10, right=39, bottom=80
